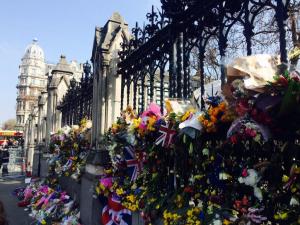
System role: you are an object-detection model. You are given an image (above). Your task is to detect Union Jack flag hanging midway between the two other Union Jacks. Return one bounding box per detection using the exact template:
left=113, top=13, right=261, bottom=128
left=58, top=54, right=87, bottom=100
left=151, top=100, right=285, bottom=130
left=124, top=146, right=146, bottom=181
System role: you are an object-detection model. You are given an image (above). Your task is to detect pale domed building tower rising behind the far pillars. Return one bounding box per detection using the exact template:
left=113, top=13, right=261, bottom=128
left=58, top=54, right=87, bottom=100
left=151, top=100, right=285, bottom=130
left=16, top=39, right=47, bottom=131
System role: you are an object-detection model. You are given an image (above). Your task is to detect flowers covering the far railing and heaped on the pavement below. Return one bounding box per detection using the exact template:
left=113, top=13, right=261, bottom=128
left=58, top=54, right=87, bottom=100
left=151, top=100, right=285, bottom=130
left=15, top=119, right=91, bottom=225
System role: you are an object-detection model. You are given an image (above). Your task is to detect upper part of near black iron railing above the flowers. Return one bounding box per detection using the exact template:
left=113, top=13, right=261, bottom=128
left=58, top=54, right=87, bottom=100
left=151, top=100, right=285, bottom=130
left=118, top=0, right=290, bottom=110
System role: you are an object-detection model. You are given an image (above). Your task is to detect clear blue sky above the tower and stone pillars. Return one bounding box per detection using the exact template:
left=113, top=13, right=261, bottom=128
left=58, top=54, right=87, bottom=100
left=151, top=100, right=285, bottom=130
left=0, top=0, right=160, bottom=124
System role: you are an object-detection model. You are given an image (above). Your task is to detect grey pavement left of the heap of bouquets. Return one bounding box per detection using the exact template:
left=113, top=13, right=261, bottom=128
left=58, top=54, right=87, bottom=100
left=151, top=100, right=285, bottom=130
left=0, top=176, right=30, bottom=225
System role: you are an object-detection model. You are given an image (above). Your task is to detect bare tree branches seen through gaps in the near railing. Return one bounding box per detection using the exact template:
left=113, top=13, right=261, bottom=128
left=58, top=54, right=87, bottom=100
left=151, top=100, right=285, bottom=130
left=190, top=0, right=300, bottom=82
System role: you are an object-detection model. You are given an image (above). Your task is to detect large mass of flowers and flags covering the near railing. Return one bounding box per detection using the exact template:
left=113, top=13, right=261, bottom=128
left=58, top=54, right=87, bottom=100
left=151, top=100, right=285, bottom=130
left=95, top=65, right=300, bottom=225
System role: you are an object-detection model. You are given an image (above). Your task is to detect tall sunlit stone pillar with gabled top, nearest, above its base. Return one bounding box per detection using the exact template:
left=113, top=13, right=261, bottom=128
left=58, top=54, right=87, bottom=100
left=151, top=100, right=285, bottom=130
left=91, top=13, right=130, bottom=146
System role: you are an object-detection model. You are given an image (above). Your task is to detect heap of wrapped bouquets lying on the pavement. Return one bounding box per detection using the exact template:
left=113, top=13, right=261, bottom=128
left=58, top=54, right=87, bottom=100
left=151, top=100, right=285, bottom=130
left=14, top=179, right=81, bottom=225
